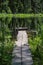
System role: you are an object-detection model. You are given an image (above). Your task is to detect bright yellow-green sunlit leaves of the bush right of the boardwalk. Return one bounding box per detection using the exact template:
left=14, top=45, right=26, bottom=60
left=29, top=36, right=42, bottom=53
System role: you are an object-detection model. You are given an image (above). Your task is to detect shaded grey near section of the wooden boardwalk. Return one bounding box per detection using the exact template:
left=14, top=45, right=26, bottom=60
left=12, top=44, right=33, bottom=65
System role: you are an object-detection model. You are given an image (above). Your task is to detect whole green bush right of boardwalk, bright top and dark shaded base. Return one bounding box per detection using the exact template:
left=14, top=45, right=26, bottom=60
left=29, top=37, right=43, bottom=65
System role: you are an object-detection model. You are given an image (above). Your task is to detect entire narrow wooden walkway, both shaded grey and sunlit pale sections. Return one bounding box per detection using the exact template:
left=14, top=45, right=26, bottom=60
left=12, top=31, right=33, bottom=65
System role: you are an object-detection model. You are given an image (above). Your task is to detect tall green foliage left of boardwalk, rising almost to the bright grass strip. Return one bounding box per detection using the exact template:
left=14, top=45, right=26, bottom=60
left=0, top=18, right=13, bottom=65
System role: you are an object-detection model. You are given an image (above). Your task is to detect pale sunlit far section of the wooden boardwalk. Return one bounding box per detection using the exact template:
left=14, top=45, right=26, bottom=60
left=15, top=31, right=28, bottom=46
